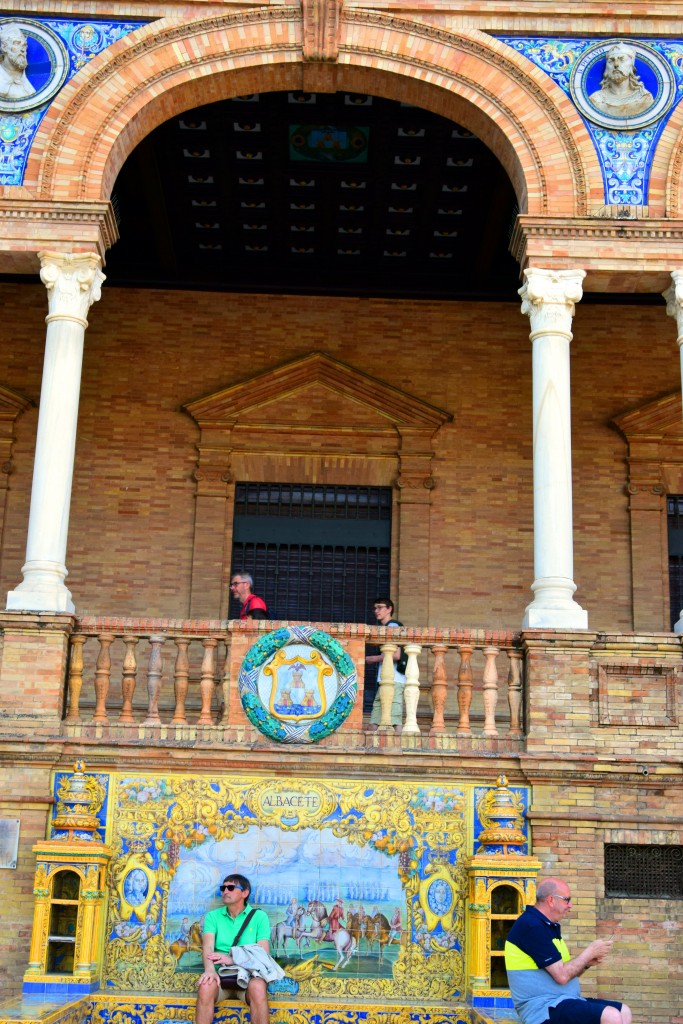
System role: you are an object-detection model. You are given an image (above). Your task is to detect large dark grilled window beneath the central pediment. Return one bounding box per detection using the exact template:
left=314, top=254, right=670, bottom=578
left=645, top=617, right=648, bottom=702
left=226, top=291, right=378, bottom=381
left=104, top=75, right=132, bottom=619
left=228, top=482, right=391, bottom=623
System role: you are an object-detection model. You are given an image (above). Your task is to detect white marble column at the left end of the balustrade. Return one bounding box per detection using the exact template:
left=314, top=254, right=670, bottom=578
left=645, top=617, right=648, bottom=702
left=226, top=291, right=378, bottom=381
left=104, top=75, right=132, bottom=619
left=7, top=252, right=104, bottom=612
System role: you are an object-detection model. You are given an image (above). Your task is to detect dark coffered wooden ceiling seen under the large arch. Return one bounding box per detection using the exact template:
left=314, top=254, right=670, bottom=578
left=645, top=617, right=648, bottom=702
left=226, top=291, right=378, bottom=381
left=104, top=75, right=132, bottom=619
left=105, top=92, right=519, bottom=299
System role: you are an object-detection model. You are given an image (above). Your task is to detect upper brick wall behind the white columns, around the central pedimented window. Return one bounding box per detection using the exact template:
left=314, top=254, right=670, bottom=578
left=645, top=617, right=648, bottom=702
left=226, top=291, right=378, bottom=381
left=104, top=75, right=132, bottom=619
left=0, top=285, right=680, bottom=630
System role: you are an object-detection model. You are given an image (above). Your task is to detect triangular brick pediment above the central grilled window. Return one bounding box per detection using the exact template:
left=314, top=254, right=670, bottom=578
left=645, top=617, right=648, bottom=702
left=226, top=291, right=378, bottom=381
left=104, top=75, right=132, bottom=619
left=183, top=352, right=453, bottom=431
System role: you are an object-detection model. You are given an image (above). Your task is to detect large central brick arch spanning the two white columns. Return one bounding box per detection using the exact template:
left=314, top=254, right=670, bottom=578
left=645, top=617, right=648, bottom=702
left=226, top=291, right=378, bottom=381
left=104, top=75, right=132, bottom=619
left=25, top=7, right=602, bottom=216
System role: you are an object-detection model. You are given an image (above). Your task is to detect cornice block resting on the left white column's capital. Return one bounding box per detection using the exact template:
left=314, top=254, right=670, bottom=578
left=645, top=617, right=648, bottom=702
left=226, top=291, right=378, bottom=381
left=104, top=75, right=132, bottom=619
left=0, top=197, right=119, bottom=273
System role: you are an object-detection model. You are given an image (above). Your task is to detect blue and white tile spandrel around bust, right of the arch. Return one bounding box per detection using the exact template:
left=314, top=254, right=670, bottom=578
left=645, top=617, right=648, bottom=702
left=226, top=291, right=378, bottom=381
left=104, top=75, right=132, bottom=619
left=499, top=36, right=683, bottom=206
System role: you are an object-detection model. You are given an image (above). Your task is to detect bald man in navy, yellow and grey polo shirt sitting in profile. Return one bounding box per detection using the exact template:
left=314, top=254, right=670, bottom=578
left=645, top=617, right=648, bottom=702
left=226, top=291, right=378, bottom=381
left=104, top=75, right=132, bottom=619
left=505, top=879, right=632, bottom=1024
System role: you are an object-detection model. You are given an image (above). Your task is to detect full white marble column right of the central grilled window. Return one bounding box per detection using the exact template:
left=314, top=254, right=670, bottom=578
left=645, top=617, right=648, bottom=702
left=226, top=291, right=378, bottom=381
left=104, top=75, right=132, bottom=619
left=519, top=268, right=588, bottom=630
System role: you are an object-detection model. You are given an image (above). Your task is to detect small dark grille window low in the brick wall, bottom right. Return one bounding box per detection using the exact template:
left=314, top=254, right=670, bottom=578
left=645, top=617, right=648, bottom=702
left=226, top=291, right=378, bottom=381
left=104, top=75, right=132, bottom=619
left=605, top=843, right=683, bottom=899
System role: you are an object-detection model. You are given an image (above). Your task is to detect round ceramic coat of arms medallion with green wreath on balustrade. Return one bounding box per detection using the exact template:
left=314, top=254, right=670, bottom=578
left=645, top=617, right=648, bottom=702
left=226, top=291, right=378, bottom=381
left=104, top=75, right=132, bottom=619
left=239, top=626, right=358, bottom=743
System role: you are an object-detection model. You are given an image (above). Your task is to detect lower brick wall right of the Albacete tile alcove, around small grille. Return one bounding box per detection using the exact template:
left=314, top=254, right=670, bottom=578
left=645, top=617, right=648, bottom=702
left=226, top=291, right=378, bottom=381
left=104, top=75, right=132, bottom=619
left=529, top=790, right=683, bottom=1024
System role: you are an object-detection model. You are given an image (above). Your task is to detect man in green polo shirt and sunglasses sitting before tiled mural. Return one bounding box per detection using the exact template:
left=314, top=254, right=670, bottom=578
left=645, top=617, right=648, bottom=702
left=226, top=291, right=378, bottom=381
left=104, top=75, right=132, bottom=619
left=196, top=874, right=270, bottom=1024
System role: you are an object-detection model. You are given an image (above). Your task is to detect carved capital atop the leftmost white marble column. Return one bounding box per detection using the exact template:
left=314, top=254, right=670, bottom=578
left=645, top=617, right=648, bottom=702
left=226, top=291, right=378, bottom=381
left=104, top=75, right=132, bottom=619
left=38, top=252, right=104, bottom=327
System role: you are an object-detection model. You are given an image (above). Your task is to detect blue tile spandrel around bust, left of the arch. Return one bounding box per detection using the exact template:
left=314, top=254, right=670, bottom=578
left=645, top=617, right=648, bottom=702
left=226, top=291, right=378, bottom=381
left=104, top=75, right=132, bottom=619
left=0, top=17, right=144, bottom=185
